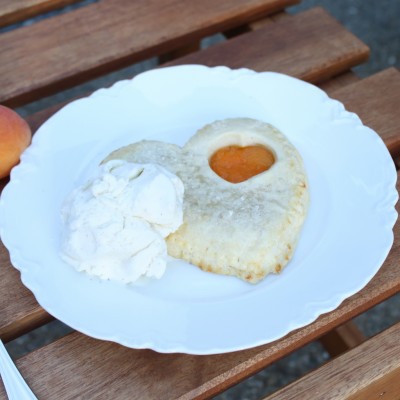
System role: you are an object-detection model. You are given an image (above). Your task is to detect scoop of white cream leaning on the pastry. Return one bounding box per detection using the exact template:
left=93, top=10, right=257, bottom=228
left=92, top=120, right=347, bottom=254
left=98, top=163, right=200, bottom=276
left=61, top=160, right=184, bottom=283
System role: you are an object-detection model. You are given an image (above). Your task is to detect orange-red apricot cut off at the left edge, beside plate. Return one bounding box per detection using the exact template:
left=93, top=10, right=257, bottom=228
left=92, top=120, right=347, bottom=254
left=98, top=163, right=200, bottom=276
left=0, top=105, right=32, bottom=179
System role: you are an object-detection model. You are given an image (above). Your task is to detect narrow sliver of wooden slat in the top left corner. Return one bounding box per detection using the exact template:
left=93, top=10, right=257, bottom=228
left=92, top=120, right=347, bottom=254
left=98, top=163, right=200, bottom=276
left=0, top=0, right=79, bottom=27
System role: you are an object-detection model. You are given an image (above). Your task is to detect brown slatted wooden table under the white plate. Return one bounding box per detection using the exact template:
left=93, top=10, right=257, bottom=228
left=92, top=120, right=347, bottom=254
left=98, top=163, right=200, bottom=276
left=0, top=0, right=400, bottom=399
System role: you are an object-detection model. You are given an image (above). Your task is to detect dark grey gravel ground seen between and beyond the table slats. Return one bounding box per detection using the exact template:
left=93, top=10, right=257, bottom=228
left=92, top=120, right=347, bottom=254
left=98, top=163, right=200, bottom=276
left=3, top=0, right=400, bottom=400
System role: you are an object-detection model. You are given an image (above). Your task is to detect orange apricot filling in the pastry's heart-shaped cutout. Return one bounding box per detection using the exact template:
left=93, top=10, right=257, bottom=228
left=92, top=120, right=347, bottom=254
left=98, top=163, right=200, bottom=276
left=209, top=145, right=275, bottom=183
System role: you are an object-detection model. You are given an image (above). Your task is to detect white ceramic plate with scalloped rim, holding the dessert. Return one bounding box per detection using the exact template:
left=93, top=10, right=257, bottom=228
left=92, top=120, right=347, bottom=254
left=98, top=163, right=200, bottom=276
left=0, top=65, right=397, bottom=354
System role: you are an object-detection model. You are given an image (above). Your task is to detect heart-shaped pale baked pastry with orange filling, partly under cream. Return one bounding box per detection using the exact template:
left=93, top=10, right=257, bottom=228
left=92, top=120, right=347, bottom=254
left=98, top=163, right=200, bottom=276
left=104, top=118, right=308, bottom=283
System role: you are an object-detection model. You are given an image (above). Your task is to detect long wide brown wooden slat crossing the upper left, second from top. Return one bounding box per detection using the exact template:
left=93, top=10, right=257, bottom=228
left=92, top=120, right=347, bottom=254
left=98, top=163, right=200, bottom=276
left=0, top=0, right=297, bottom=107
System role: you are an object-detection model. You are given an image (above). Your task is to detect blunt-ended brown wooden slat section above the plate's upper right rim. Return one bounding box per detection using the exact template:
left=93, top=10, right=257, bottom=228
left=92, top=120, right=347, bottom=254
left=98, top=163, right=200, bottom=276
left=172, top=7, right=369, bottom=83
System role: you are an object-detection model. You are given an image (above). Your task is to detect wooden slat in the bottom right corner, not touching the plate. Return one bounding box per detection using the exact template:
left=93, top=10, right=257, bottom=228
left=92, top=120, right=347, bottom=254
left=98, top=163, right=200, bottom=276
left=265, top=323, right=400, bottom=400
